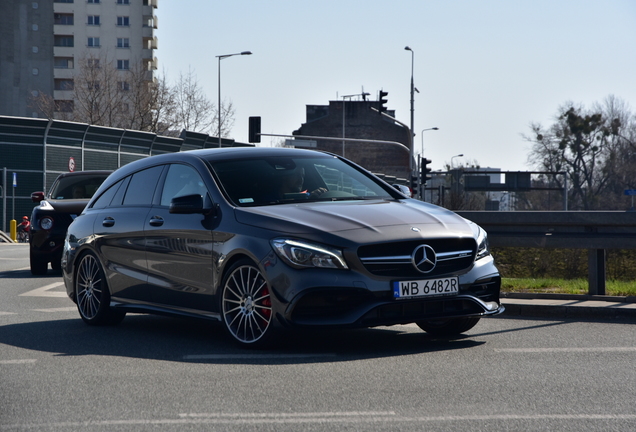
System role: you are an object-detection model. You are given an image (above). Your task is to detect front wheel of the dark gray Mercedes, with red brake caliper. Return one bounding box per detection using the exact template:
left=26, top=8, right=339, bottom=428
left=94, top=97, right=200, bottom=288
left=219, top=260, right=274, bottom=349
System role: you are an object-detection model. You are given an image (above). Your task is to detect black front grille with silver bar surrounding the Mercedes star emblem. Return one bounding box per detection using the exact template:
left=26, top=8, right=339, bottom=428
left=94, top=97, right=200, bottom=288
left=358, top=238, right=477, bottom=278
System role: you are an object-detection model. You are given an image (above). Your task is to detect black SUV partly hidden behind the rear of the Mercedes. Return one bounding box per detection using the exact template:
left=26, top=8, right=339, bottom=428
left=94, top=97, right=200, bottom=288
left=29, top=171, right=112, bottom=275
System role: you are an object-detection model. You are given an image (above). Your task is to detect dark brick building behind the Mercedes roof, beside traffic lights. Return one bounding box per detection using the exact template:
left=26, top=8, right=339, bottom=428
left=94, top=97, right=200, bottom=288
left=293, top=100, right=409, bottom=178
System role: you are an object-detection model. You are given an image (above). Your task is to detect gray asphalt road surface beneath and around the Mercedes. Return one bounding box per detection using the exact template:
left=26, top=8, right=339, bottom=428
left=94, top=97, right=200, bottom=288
left=0, top=245, right=636, bottom=432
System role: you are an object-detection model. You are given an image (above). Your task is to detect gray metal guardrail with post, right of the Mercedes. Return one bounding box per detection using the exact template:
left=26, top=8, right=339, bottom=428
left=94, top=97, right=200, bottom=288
left=456, top=210, right=636, bottom=295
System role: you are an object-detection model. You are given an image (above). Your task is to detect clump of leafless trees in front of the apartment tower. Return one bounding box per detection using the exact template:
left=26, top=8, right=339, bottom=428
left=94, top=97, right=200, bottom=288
left=31, top=55, right=234, bottom=136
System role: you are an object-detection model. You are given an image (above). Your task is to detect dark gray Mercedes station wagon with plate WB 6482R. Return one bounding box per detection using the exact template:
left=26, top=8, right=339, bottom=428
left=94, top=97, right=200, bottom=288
left=62, top=148, right=504, bottom=347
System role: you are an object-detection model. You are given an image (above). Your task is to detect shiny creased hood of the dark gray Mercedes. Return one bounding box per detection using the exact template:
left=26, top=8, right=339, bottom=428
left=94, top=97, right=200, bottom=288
left=236, top=200, right=473, bottom=241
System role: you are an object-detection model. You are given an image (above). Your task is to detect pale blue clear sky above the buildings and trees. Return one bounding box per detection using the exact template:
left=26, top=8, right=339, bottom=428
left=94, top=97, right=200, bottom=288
left=155, top=0, right=636, bottom=171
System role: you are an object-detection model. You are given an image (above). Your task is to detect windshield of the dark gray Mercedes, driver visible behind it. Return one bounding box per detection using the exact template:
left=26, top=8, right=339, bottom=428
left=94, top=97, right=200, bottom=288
left=211, top=156, right=393, bottom=207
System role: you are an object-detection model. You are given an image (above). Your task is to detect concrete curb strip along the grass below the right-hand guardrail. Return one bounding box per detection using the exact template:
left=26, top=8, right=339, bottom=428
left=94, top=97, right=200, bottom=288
left=501, top=293, right=636, bottom=322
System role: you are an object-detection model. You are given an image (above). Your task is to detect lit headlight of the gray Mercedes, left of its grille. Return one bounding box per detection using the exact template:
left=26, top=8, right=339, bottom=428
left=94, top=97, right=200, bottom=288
left=271, top=238, right=349, bottom=269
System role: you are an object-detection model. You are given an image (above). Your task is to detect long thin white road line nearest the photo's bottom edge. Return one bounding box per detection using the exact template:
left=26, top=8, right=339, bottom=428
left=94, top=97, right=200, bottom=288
left=0, top=411, right=636, bottom=430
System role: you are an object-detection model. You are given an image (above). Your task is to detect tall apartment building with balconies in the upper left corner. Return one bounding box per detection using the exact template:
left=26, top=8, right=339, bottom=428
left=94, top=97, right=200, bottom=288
left=0, top=0, right=158, bottom=117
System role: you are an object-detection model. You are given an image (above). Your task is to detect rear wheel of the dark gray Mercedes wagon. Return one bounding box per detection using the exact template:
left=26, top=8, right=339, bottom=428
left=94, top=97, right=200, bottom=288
left=74, top=252, right=126, bottom=326
